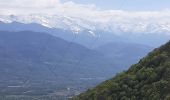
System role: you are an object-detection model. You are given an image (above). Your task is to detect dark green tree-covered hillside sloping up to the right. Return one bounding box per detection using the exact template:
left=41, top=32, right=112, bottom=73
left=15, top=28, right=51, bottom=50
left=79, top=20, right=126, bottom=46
left=75, top=42, right=170, bottom=100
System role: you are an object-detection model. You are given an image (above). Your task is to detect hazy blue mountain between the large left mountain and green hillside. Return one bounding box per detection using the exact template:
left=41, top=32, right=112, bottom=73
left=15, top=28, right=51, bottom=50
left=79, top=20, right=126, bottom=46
left=95, top=42, right=153, bottom=70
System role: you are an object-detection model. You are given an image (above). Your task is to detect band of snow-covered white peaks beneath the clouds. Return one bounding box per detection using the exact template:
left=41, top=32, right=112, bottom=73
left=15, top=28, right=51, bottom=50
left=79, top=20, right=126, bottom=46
left=0, top=14, right=170, bottom=36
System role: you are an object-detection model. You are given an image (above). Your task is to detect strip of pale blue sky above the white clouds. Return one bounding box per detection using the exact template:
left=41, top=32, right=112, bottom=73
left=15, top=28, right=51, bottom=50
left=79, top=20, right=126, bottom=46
left=63, top=0, right=170, bottom=10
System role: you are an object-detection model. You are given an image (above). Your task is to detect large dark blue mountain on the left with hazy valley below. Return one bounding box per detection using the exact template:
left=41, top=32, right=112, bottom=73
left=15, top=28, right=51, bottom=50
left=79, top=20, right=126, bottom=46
left=0, top=31, right=117, bottom=95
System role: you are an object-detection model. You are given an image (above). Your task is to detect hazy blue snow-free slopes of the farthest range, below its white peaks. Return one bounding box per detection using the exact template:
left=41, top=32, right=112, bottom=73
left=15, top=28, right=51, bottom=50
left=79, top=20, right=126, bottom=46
left=0, top=21, right=170, bottom=48
